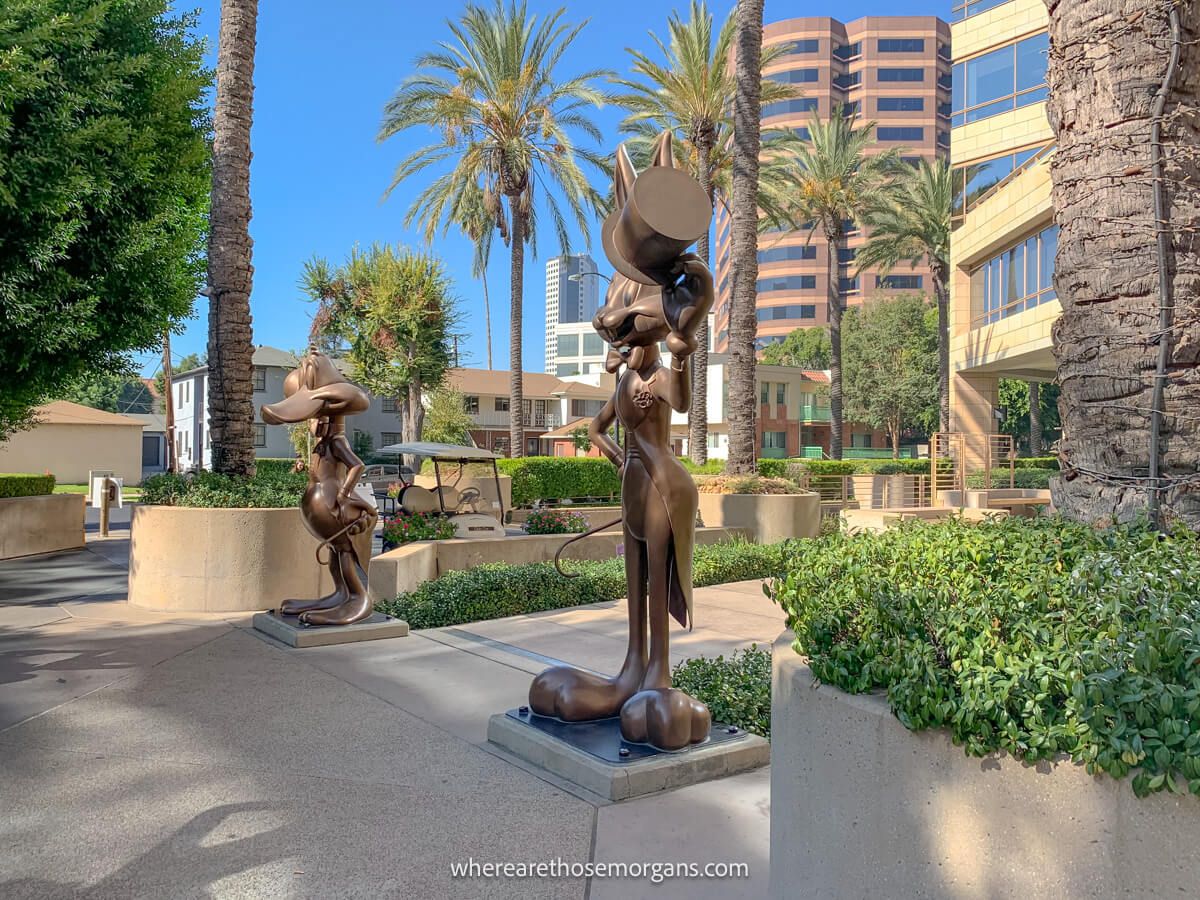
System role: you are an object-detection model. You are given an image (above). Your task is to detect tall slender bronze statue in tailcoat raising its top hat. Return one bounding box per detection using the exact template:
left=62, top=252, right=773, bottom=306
left=529, top=133, right=713, bottom=750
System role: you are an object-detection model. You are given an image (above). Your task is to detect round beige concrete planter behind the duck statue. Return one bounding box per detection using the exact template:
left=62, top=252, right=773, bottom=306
left=130, top=505, right=371, bottom=612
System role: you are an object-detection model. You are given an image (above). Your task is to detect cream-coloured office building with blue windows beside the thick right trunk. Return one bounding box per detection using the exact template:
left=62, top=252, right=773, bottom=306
left=950, top=0, right=1062, bottom=466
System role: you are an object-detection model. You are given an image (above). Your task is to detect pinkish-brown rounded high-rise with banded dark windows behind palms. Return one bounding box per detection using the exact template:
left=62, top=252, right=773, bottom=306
left=713, top=16, right=950, bottom=352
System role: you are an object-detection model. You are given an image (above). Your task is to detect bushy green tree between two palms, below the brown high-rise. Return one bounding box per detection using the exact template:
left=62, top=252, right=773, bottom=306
left=844, top=294, right=937, bottom=457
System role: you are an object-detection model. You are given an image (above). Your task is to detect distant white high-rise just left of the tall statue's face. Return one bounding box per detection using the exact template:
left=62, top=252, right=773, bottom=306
left=546, top=253, right=606, bottom=377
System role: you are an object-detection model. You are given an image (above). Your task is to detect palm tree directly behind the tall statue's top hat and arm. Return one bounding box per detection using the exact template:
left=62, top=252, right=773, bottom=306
left=614, top=0, right=796, bottom=464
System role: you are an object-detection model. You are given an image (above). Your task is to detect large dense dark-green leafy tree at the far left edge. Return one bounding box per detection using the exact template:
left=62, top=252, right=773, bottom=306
left=0, top=0, right=211, bottom=440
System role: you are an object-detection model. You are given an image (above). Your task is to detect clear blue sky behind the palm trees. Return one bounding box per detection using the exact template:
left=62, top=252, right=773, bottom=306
left=150, top=0, right=931, bottom=372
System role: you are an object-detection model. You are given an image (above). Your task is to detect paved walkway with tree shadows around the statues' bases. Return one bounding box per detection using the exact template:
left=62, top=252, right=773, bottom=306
left=0, top=535, right=782, bottom=900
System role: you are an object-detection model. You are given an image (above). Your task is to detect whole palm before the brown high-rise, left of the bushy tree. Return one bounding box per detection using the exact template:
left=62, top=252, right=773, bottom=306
left=787, top=112, right=902, bottom=460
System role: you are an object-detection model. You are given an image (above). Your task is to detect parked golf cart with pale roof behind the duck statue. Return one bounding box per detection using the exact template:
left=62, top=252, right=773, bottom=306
left=376, top=442, right=504, bottom=538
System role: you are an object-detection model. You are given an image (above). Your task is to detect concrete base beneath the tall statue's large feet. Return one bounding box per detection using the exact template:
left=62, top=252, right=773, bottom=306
left=487, top=713, right=770, bottom=800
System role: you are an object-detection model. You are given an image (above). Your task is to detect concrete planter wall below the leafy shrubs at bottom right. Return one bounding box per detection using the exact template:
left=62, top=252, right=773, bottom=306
left=770, top=634, right=1200, bottom=900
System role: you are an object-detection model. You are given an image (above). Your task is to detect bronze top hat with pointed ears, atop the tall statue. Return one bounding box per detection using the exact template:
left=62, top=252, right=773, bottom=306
left=601, top=131, right=713, bottom=284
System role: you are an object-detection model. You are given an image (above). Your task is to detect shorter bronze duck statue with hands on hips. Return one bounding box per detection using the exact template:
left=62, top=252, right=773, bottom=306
left=263, top=350, right=378, bottom=625
